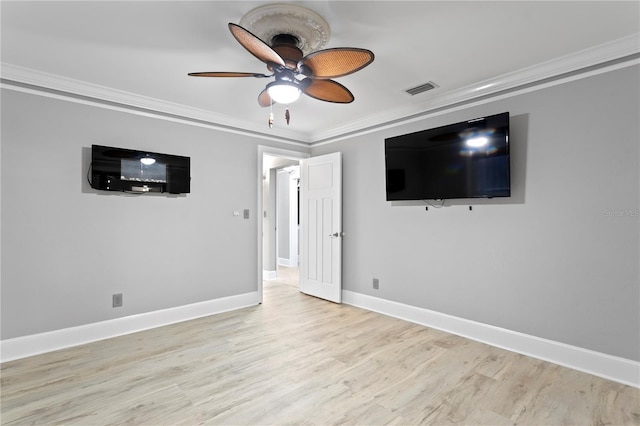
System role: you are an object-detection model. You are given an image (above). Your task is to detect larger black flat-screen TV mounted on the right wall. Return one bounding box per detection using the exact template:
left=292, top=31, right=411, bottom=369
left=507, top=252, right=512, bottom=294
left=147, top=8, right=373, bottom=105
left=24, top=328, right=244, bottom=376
left=385, top=112, right=511, bottom=201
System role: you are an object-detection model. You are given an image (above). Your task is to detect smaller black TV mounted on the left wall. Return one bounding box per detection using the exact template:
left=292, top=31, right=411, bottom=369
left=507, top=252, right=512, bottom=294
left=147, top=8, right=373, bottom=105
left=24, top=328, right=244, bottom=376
left=89, top=145, right=191, bottom=194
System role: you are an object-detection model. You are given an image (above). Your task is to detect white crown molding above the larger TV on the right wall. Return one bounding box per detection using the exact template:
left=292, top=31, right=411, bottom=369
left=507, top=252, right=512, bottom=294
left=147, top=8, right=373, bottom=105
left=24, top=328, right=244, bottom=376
left=311, top=33, right=640, bottom=146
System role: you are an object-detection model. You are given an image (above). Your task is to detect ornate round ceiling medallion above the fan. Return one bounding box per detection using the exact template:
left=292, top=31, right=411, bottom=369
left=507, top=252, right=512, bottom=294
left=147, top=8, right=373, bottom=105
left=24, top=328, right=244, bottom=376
left=240, top=3, right=331, bottom=56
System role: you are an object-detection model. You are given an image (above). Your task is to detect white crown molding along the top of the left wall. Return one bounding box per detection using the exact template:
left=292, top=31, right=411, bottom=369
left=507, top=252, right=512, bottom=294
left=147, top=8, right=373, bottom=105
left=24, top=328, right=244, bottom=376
left=0, top=62, right=309, bottom=146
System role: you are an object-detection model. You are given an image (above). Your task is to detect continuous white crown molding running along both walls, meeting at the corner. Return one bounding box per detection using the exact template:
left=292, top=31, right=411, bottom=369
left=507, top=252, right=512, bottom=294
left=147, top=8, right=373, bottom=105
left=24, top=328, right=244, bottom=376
left=0, top=33, right=640, bottom=147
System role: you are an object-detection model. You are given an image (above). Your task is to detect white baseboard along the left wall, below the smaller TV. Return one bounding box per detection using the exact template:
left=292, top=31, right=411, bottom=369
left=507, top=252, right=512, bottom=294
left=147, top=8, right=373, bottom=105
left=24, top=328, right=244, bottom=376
left=0, top=292, right=259, bottom=362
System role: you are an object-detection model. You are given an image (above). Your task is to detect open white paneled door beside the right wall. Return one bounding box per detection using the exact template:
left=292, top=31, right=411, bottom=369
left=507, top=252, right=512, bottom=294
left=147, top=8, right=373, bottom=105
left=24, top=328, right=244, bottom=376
left=300, top=152, right=342, bottom=303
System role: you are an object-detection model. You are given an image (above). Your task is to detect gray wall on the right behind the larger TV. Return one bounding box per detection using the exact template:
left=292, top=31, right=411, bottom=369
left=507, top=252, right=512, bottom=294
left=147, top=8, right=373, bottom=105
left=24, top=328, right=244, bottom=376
left=312, top=66, right=640, bottom=360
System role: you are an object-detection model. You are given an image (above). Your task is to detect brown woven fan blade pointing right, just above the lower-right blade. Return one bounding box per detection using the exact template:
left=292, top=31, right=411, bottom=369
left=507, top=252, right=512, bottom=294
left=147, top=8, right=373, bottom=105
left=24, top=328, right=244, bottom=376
left=298, top=47, right=374, bottom=78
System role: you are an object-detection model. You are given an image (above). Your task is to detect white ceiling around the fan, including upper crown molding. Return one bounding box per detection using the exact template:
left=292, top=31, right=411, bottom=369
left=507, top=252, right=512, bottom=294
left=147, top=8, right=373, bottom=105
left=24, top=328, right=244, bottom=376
left=1, top=0, right=640, bottom=142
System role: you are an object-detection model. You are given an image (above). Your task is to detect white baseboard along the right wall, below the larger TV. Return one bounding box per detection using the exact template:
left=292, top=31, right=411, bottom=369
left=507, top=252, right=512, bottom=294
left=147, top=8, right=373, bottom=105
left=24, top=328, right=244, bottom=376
left=342, top=290, right=640, bottom=388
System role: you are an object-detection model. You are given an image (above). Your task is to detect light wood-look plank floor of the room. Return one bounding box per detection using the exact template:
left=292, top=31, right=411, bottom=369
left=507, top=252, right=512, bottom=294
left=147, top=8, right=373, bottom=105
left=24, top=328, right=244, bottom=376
left=1, top=282, right=640, bottom=425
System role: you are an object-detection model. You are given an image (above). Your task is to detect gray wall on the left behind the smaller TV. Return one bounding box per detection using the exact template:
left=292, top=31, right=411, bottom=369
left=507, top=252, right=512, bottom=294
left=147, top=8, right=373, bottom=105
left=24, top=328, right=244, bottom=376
left=1, top=90, right=304, bottom=339
